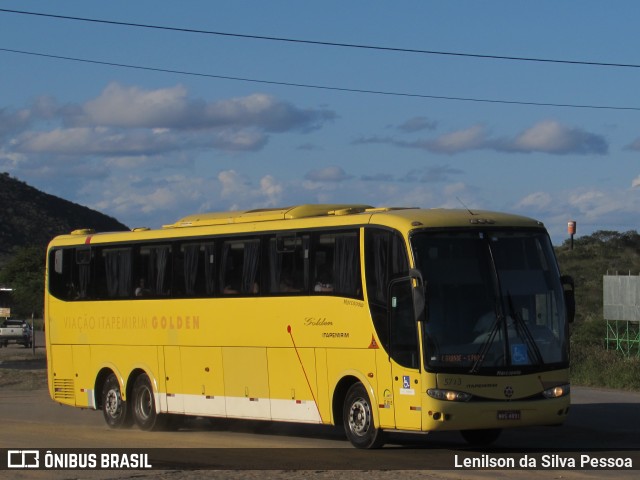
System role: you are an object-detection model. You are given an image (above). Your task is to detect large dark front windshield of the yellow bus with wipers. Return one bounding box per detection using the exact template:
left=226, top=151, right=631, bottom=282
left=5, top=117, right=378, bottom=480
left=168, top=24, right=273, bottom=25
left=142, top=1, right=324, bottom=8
left=412, top=230, right=568, bottom=375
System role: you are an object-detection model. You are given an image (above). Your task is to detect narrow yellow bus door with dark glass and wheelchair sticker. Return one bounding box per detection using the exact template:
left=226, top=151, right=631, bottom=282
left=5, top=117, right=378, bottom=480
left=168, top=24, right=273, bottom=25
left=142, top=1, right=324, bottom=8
left=389, top=277, right=422, bottom=430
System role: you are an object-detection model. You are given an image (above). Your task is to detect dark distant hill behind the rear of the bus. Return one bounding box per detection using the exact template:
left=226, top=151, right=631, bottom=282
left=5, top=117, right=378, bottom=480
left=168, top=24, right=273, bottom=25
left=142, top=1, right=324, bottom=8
left=0, top=173, right=128, bottom=264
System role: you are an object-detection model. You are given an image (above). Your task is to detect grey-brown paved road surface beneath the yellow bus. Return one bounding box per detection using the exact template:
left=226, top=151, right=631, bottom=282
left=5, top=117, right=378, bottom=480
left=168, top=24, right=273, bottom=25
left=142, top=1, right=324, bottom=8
left=0, top=388, right=640, bottom=473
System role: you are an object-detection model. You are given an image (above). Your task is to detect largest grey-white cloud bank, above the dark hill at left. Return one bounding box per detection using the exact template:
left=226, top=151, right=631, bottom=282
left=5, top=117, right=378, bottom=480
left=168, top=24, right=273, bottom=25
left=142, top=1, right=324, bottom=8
left=0, top=83, right=336, bottom=162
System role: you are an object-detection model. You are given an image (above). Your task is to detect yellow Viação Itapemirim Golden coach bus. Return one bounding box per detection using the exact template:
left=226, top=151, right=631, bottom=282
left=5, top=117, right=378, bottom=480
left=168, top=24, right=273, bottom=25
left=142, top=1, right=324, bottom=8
left=45, top=205, right=574, bottom=448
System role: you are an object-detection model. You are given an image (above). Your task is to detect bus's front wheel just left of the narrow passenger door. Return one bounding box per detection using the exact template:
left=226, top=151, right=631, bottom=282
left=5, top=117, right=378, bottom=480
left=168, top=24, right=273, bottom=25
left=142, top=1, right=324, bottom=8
left=343, top=382, right=384, bottom=448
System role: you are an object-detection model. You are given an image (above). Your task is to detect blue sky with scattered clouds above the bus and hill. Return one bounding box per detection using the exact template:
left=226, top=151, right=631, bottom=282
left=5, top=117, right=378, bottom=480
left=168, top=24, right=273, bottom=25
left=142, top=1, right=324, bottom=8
left=0, top=0, right=640, bottom=244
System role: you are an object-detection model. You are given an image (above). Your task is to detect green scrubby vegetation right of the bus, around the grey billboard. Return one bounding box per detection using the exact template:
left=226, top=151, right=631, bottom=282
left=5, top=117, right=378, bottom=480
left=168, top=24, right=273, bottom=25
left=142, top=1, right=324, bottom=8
left=556, top=231, right=640, bottom=390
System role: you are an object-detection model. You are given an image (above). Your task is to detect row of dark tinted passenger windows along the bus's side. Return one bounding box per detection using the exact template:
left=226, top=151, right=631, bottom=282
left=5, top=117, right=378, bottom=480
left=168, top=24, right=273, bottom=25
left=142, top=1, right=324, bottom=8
left=49, top=231, right=362, bottom=300
